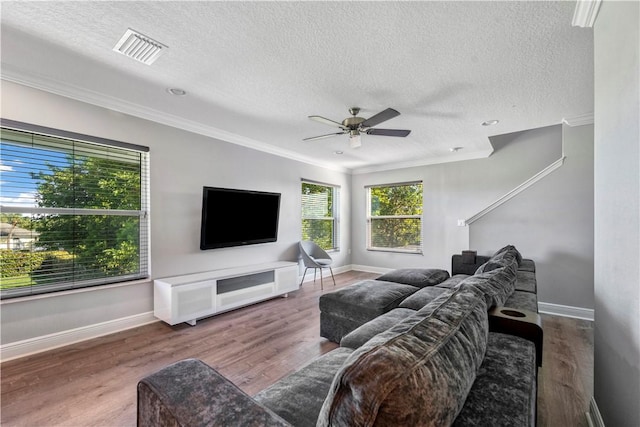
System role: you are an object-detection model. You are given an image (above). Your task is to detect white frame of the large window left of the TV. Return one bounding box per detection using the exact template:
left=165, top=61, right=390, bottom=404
left=0, top=118, right=151, bottom=301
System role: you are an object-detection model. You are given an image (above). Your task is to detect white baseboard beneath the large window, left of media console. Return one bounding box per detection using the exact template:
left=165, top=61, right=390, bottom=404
left=0, top=311, right=159, bottom=362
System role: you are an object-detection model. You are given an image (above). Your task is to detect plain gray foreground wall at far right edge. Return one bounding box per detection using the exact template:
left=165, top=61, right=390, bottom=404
left=594, top=1, right=640, bottom=427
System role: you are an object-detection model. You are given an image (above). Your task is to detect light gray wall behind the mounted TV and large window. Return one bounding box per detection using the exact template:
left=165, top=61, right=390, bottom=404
left=1, top=81, right=351, bottom=344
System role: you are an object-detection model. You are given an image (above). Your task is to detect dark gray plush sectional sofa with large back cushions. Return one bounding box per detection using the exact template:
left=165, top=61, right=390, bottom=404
left=138, top=247, right=539, bottom=426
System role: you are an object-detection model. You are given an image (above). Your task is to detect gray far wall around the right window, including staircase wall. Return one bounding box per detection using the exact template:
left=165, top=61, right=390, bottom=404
left=352, top=125, right=593, bottom=310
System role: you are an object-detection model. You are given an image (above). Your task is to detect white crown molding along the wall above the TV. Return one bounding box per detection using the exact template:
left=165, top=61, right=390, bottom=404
left=1, top=64, right=351, bottom=173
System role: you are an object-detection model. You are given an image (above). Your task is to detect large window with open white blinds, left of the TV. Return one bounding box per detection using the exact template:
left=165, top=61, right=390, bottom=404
left=0, top=120, right=149, bottom=298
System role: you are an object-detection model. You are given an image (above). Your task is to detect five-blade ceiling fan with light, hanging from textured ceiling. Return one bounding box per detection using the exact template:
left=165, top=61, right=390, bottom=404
left=303, top=107, right=411, bottom=148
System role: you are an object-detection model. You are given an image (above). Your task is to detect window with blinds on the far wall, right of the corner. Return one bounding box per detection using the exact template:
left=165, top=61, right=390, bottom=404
left=366, top=182, right=422, bottom=253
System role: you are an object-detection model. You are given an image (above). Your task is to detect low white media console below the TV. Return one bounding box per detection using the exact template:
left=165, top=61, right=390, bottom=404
left=153, top=261, right=300, bottom=326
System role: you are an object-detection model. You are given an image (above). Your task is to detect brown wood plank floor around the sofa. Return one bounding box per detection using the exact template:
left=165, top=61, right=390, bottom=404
left=0, top=271, right=593, bottom=427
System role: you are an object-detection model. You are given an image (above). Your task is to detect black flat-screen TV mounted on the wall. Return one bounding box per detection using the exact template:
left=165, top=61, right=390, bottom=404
left=200, top=187, right=280, bottom=250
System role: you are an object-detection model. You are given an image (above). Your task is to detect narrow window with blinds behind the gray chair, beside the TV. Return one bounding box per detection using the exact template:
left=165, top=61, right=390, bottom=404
left=302, top=181, right=340, bottom=250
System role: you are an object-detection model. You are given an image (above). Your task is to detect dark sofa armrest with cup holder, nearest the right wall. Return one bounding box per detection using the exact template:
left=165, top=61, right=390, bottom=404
left=489, top=307, right=543, bottom=366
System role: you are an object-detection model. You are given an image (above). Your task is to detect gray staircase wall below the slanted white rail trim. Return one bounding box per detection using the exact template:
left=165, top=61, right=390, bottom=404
left=469, top=125, right=594, bottom=309
